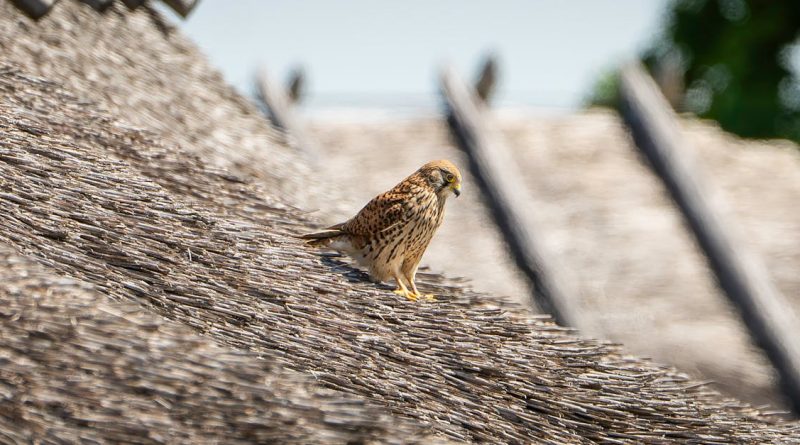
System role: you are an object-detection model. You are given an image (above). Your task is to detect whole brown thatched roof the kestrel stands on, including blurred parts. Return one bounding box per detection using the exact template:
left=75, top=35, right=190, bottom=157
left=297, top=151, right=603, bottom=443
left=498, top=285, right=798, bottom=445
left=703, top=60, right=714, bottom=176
left=0, top=2, right=800, bottom=443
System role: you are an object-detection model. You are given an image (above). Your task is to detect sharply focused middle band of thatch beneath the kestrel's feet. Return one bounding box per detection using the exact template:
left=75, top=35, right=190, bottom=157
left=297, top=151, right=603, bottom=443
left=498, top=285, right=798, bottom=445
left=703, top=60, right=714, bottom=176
left=0, top=61, right=798, bottom=443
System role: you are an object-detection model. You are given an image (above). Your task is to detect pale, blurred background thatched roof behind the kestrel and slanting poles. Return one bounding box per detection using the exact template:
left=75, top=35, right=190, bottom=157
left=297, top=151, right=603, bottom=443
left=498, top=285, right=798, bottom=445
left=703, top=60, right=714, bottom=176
left=310, top=110, right=800, bottom=407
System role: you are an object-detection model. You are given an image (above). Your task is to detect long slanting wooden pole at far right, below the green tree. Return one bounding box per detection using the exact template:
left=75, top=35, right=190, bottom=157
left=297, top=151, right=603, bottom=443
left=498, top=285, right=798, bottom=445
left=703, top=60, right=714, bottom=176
left=621, top=65, right=800, bottom=413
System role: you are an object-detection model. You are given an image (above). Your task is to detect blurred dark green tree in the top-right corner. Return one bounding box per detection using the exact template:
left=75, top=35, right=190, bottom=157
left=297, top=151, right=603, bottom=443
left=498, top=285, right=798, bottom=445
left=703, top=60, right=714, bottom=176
left=592, top=0, right=800, bottom=141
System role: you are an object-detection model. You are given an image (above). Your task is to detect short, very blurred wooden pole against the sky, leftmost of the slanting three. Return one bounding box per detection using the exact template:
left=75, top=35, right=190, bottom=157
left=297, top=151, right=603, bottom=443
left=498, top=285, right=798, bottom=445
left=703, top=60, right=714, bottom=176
left=256, top=68, right=319, bottom=160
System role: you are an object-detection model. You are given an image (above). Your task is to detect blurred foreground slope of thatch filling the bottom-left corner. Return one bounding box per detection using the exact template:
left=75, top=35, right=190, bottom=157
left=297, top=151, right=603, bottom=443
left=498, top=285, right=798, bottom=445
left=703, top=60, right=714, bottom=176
left=0, top=245, right=444, bottom=444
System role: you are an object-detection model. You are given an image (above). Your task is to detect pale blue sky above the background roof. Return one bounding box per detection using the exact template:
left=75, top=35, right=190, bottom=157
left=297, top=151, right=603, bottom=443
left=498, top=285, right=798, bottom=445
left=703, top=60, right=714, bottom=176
left=166, top=0, right=667, bottom=109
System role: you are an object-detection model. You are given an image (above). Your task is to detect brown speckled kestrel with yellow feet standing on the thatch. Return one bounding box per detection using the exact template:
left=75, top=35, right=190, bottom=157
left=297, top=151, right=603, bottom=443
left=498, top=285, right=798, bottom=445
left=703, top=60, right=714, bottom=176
left=303, top=160, right=461, bottom=301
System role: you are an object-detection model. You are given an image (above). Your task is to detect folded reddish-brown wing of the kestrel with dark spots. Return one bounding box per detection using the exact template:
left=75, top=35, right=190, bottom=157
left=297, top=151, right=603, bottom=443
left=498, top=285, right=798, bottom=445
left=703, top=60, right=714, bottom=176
left=341, top=191, right=408, bottom=238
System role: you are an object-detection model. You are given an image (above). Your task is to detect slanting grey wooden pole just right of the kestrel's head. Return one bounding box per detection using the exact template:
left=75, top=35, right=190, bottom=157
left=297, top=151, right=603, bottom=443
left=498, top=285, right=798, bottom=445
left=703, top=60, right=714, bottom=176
left=441, top=64, right=575, bottom=326
